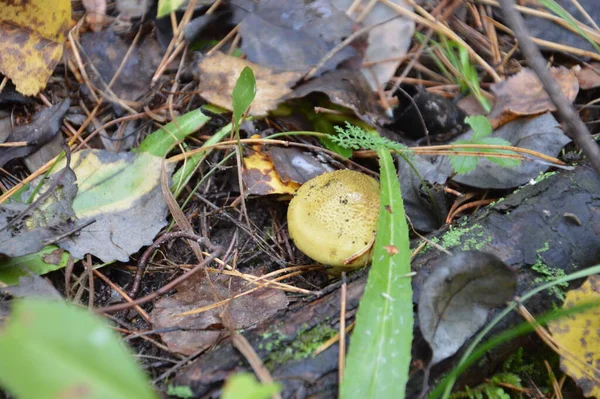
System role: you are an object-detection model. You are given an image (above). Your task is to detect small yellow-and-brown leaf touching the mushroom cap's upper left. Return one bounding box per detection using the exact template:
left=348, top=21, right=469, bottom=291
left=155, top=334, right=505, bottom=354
left=242, top=145, right=300, bottom=195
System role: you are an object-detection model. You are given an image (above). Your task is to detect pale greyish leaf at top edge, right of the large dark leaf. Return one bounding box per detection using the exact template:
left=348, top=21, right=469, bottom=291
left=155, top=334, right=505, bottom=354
left=332, top=0, right=415, bottom=91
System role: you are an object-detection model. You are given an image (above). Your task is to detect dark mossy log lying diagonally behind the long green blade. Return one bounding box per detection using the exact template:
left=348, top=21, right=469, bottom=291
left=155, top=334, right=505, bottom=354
left=173, top=166, right=600, bottom=398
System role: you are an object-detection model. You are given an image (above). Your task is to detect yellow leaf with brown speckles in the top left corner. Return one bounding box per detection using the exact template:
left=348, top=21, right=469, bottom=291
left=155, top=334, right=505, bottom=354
left=0, top=0, right=71, bottom=96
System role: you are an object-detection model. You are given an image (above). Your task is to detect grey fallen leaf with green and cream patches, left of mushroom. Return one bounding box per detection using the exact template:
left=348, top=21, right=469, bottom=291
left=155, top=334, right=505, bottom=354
left=49, top=150, right=172, bottom=262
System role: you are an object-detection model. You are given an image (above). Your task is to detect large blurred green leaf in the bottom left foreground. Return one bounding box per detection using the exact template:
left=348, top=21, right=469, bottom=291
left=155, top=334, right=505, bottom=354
left=0, top=300, right=157, bottom=399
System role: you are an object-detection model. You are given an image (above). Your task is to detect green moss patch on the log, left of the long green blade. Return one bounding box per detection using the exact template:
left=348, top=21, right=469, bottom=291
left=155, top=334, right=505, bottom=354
left=259, top=325, right=338, bottom=370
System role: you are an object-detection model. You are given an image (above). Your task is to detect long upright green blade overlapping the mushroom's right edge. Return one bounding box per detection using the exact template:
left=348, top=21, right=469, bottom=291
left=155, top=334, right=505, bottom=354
left=341, top=149, right=413, bottom=399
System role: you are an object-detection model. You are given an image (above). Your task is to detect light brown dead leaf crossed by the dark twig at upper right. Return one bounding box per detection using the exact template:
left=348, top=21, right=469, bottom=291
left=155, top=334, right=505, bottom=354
left=488, top=66, right=579, bottom=128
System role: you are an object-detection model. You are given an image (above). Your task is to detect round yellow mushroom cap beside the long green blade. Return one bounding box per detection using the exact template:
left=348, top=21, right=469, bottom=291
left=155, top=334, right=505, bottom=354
left=287, top=169, right=379, bottom=267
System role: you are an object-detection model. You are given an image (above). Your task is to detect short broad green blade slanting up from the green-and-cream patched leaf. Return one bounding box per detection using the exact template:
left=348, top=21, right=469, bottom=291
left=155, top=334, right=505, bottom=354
left=137, top=108, right=211, bottom=157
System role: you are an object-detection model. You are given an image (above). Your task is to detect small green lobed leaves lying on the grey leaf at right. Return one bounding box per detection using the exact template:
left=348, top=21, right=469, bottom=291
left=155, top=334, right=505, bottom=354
left=450, top=115, right=521, bottom=174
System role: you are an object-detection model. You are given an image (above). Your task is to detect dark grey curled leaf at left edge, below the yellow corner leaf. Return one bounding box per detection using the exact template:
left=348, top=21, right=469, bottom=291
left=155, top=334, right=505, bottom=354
left=0, top=98, right=71, bottom=167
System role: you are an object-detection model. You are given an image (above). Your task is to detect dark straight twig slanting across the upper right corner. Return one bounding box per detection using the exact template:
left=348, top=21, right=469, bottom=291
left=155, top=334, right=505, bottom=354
left=500, top=0, right=600, bottom=173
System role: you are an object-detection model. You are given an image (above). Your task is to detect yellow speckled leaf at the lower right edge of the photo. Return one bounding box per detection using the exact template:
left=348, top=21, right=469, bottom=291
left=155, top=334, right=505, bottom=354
left=548, top=275, right=600, bottom=398
